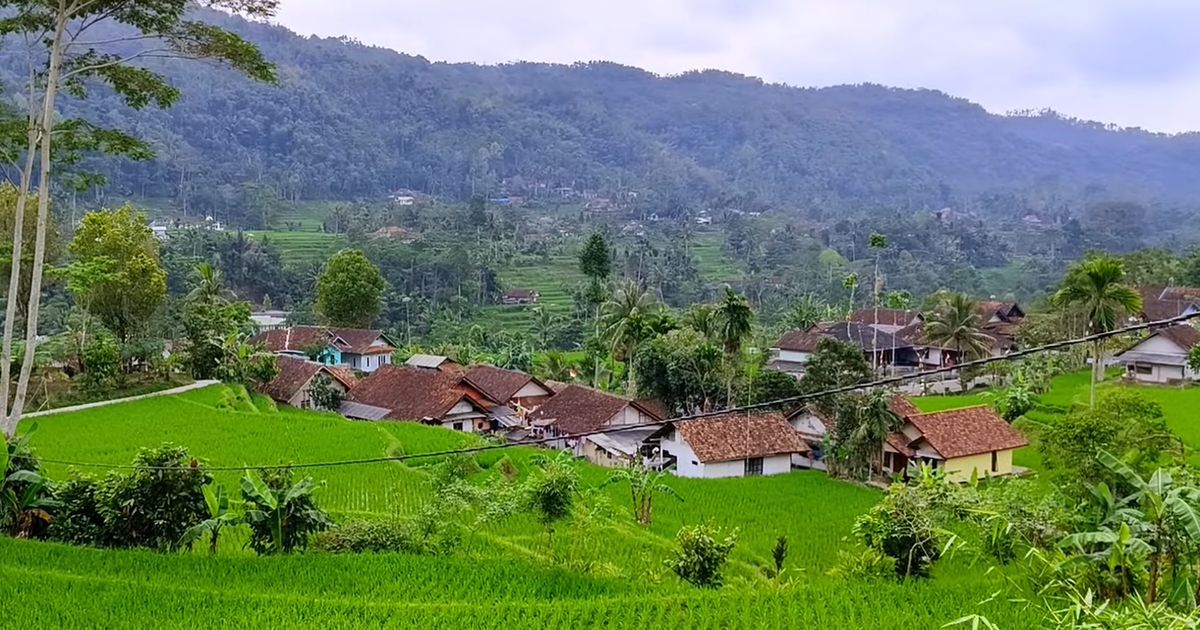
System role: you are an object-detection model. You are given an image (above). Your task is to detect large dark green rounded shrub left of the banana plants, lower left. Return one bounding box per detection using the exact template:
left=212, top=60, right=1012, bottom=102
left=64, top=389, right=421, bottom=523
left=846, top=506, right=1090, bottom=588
left=96, top=444, right=212, bottom=551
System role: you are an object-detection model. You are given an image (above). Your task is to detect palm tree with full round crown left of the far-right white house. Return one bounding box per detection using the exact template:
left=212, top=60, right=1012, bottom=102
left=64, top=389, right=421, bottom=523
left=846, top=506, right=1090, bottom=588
left=1050, top=257, right=1141, bottom=407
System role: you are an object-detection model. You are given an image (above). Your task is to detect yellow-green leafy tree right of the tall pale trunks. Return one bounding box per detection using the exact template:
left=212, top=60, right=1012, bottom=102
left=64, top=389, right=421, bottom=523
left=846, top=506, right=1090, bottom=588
left=70, top=204, right=167, bottom=342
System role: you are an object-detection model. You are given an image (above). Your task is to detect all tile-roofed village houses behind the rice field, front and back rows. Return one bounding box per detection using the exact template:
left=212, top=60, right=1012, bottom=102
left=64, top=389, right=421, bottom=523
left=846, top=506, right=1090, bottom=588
left=250, top=279, right=1200, bottom=481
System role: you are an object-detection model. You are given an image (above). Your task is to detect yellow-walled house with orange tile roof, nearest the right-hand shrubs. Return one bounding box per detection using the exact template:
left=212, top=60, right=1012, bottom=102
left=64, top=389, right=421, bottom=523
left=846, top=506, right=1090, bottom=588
left=883, top=397, right=1030, bottom=481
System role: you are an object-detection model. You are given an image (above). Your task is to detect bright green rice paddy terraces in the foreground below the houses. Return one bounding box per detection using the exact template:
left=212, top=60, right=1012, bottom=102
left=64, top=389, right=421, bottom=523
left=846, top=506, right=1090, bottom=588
left=0, top=386, right=1046, bottom=629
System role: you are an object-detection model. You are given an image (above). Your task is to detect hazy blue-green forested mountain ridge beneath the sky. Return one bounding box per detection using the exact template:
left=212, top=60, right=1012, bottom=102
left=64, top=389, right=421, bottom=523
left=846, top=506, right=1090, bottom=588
left=35, top=9, right=1200, bottom=212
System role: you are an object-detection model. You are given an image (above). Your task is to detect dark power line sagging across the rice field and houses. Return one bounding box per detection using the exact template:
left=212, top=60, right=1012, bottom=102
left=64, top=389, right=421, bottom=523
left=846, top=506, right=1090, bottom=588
left=41, top=312, right=1200, bottom=473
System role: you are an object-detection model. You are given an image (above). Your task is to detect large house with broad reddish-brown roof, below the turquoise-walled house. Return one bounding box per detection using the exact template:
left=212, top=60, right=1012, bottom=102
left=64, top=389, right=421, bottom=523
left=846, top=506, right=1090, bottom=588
left=340, top=365, right=499, bottom=433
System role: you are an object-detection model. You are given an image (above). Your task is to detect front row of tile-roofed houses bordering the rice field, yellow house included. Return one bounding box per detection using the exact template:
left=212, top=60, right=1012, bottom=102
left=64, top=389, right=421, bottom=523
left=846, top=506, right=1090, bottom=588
left=253, top=320, right=1026, bottom=479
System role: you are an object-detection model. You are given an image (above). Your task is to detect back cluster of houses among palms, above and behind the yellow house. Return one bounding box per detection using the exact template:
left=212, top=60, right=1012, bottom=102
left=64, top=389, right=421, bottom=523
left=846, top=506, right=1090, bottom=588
left=769, top=301, right=1025, bottom=377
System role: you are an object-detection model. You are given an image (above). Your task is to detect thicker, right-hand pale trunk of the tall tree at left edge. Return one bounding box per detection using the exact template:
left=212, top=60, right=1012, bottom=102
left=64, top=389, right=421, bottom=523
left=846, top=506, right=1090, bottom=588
left=4, top=6, right=71, bottom=436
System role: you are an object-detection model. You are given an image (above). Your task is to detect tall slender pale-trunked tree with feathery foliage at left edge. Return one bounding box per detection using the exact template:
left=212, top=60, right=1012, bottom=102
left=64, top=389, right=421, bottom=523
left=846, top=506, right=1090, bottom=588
left=0, top=0, right=278, bottom=436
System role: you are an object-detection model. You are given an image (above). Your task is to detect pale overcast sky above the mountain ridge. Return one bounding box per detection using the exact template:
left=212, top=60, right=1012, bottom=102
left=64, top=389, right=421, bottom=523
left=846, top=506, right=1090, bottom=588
left=278, top=0, right=1200, bottom=131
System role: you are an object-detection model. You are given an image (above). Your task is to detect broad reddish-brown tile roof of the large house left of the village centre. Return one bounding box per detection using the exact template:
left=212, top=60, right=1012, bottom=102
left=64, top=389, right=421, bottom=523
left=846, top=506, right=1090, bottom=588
left=347, top=365, right=497, bottom=420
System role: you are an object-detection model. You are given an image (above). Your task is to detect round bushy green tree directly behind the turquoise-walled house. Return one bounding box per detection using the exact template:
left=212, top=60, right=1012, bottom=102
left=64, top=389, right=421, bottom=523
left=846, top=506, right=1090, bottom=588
left=317, top=250, right=388, bottom=328
